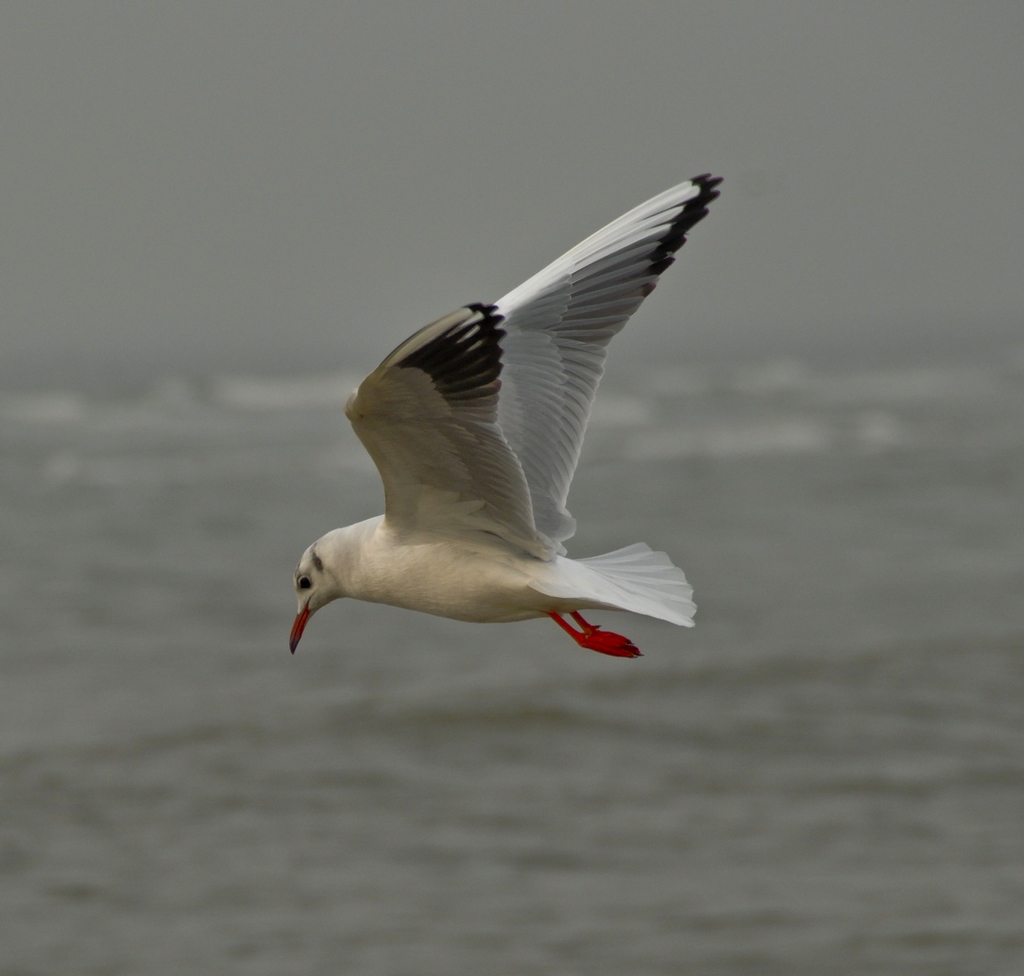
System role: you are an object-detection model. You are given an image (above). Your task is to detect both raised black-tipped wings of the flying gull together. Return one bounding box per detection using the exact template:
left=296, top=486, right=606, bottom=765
left=345, top=175, right=721, bottom=559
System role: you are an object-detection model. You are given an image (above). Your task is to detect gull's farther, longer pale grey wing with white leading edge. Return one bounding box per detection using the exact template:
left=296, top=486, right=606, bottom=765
left=497, top=174, right=721, bottom=549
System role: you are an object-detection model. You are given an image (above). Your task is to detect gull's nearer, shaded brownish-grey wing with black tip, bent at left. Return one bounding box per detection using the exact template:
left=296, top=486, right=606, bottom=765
left=345, top=305, right=553, bottom=559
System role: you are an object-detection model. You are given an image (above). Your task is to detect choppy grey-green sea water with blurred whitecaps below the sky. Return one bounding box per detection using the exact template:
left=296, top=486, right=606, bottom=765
left=0, top=356, right=1024, bottom=976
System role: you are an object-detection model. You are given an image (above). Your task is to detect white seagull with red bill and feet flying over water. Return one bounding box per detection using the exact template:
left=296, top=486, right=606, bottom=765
left=290, top=174, right=721, bottom=657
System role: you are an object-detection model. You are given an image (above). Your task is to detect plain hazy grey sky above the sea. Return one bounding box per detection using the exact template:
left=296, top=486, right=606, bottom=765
left=0, top=0, right=1024, bottom=386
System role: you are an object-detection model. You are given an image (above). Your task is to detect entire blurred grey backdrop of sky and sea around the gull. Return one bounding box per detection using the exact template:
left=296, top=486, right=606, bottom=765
left=0, top=0, right=1024, bottom=976
